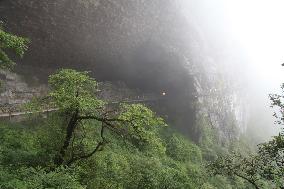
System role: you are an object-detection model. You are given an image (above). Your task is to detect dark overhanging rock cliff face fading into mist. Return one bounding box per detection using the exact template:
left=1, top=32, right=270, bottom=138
left=0, top=0, right=248, bottom=139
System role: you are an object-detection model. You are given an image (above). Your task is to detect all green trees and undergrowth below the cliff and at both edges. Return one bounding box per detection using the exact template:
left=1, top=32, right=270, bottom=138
left=0, top=24, right=284, bottom=189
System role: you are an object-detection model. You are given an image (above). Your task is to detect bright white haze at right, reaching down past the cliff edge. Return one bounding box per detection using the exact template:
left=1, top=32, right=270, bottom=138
left=183, top=0, right=284, bottom=140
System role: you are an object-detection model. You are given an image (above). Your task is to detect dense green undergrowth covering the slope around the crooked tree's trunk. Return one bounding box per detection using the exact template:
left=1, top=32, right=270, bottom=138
left=0, top=114, right=250, bottom=189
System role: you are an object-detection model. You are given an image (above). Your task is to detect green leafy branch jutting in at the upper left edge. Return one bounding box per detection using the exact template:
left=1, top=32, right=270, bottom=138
left=0, top=22, right=29, bottom=69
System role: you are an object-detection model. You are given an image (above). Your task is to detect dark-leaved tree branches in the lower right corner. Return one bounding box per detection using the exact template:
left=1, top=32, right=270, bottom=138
left=209, top=81, right=284, bottom=189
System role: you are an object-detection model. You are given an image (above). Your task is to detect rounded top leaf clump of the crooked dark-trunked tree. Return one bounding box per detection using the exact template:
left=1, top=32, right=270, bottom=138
left=48, top=69, right=104, bottom=113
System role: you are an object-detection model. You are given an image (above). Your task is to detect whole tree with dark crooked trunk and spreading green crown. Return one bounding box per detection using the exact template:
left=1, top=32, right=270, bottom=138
left=28, top=69, right=166, bottom=166
